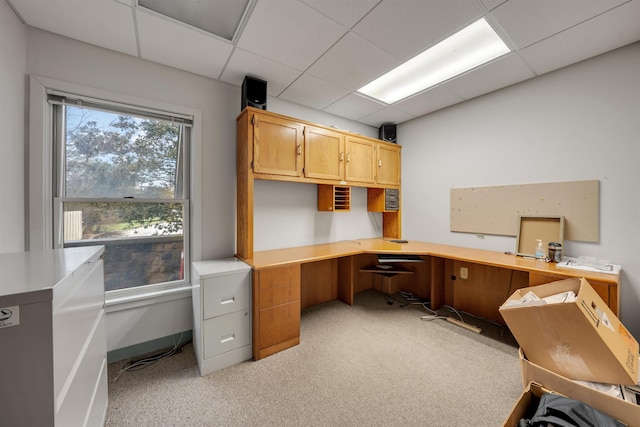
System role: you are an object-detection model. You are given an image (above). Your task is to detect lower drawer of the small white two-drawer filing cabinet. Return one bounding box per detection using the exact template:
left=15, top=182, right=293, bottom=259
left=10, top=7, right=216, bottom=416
left=203, top=308, right=251, bottom=359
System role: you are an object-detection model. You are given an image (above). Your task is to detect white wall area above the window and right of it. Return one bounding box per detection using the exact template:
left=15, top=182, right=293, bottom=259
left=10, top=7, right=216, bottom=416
left=26, top=28, right=239, bottom=258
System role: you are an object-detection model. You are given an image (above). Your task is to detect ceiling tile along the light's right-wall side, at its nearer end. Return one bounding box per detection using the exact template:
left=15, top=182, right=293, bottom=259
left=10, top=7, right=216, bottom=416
left=444, top=53, right=535, bottom=99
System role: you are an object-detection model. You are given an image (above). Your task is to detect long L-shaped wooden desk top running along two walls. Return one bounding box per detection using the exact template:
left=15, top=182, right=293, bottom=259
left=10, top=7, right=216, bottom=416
left=243, top=238, right=620, bottom=285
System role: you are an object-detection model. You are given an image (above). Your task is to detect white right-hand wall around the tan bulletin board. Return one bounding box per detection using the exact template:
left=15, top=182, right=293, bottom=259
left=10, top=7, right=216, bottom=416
left=398, top=43, right=640, bottom=339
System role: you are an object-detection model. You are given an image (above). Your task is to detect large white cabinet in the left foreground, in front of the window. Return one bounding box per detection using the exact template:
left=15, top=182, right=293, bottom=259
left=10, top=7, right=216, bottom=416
left=0, top=246, right=107, bottom=427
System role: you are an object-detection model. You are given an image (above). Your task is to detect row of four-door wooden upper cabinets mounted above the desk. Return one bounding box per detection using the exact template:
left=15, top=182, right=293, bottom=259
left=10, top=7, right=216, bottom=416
left=244, top=107, right=401, bottom=188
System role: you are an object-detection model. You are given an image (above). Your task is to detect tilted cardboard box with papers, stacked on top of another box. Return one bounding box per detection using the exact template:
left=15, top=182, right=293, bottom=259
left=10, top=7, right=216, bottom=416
left=500, top=278, right=639, bottom=384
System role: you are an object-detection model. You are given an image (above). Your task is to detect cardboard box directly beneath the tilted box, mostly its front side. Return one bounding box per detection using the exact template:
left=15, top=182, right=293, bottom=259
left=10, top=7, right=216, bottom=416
left=519, top=349, right=640, bottom=426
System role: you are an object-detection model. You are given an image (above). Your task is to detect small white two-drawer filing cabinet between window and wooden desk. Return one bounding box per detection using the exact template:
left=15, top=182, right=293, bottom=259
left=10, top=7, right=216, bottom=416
left=192, top=258, right=252, bottom=375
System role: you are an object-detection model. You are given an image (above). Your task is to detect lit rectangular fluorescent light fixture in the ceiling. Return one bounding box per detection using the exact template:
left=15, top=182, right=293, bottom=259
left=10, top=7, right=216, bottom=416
left=358, top=18, right=509, bottom=104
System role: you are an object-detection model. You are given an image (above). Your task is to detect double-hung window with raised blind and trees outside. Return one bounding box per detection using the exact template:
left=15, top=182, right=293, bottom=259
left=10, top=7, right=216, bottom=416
left=49, top=94, right=192, bottom=291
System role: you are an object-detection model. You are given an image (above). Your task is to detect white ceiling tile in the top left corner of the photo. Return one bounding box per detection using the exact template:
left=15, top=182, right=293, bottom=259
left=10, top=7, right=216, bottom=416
left=11, top=0, right=138, bottom=56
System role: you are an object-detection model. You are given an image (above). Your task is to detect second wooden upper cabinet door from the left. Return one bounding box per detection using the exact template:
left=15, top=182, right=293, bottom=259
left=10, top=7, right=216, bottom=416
left=304, top=126, right=345, bottom=181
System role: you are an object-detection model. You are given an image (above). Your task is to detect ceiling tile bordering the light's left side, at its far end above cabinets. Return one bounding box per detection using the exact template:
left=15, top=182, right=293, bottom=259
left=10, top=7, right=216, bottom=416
left=307, top=33, right=399, bottom=90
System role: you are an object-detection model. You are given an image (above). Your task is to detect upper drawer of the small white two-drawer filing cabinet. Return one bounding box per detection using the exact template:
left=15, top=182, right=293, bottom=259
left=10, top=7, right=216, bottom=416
left=202, top=271, right=251, bottom=319
